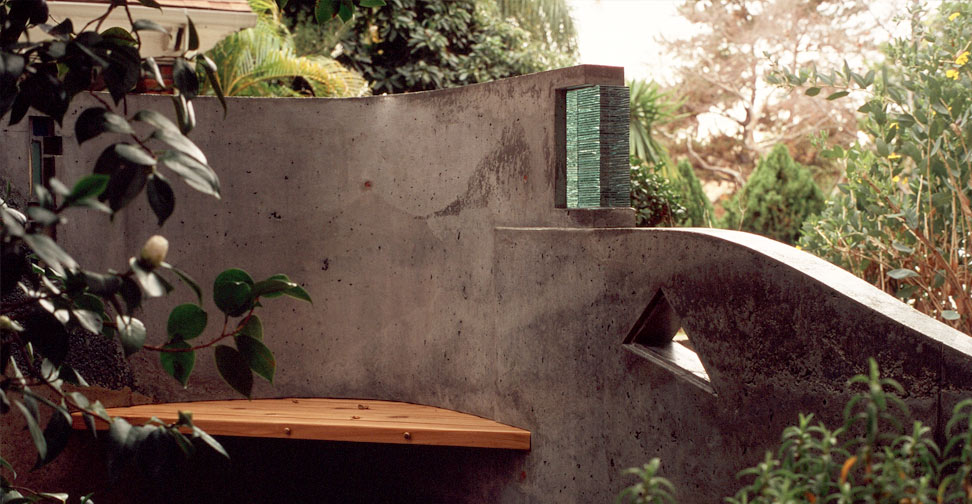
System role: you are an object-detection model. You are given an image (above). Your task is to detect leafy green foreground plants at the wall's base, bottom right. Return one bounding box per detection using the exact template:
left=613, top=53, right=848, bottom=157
left=618, top=359, right=972, bottom=504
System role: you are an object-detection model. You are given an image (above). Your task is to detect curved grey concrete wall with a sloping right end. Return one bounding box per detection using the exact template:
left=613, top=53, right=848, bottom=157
left=0, top=66, right=972, bottom=503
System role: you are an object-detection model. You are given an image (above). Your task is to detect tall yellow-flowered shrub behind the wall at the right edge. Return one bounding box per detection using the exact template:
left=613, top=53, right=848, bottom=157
left=787, top=2, right=972, bottom=334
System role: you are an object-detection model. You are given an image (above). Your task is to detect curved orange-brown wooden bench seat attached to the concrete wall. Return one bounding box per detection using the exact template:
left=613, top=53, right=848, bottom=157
left=73, top=398, right=530, bottom=450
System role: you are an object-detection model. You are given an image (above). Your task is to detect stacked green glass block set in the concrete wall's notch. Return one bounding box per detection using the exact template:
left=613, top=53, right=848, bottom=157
left=566, top=86, right=631, bottom=208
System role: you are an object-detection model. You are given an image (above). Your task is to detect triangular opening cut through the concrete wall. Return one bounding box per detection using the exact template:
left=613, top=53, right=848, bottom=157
left=624, top=289, right=715, bottom=395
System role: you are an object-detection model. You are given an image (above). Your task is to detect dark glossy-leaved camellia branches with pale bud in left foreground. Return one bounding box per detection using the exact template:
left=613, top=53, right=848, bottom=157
left=0, top=0, right=382, bottom=502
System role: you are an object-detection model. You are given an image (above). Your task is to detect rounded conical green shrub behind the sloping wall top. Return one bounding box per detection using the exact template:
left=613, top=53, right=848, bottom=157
left=724, top=144, right=824, bottom=244
